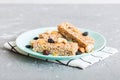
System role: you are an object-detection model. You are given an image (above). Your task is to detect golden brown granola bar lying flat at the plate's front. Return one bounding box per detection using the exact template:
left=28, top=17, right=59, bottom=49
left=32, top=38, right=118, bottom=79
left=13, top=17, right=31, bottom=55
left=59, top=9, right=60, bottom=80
left=32, top=39, right=78, bottom=56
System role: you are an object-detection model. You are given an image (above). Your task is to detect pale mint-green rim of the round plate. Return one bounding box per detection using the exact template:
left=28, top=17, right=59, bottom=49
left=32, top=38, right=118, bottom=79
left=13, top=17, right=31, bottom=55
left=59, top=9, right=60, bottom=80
left=16, top=27, right=106, bottom=60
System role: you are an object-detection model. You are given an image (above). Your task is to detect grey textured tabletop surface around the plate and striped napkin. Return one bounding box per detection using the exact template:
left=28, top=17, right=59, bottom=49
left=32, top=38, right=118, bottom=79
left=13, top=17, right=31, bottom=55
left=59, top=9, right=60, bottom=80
left=0, top=4, right=120, bottom=80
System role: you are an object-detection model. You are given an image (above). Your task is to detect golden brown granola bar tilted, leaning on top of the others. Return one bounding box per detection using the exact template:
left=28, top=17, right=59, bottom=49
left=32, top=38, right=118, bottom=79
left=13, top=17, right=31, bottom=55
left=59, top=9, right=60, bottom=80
left=58, top=23, right=94, bottom=52
